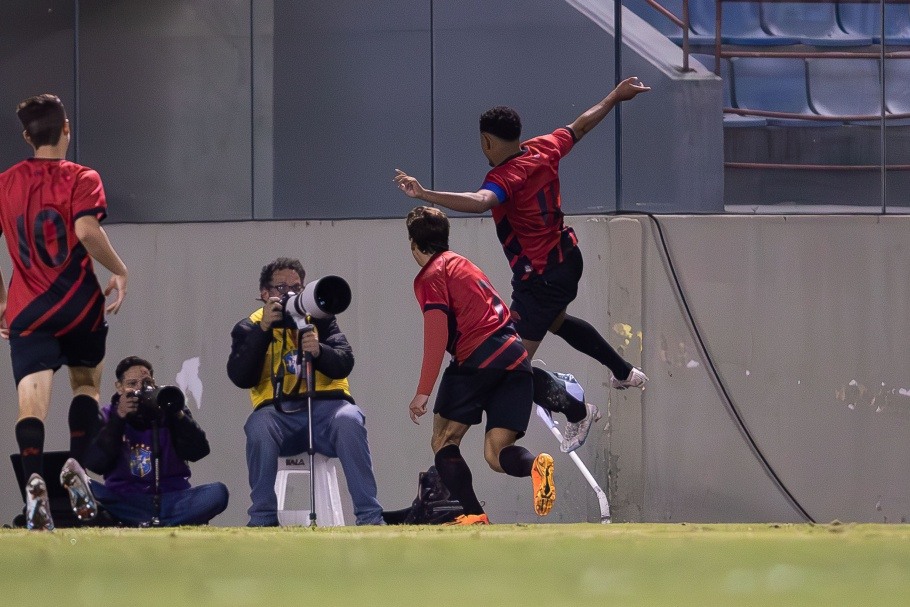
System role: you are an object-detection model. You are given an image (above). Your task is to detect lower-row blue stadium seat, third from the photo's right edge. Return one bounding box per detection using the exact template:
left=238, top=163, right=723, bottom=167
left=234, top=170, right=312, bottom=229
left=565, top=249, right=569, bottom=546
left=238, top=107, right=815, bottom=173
left=730, top=57, right=833, bottom=127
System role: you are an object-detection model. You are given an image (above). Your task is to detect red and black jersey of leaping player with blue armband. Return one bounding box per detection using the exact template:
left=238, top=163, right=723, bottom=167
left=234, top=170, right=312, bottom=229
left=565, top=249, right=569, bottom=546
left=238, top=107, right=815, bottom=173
left=481, top=127, right=578, bottom=279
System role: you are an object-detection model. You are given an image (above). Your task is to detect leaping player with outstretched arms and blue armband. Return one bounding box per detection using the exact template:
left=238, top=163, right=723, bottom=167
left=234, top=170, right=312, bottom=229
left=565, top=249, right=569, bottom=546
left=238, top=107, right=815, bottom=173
left=395, top=77, right=651, bottom=451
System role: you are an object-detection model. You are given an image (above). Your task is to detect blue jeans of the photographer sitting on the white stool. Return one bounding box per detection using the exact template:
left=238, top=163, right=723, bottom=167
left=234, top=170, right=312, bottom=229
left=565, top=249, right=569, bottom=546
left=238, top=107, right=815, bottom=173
left=244, top=399, right=383, bottom=527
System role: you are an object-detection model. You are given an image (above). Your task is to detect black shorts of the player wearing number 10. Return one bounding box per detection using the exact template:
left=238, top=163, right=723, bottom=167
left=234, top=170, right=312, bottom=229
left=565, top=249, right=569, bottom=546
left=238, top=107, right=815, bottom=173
left=9, top=323, right=107, bottom=386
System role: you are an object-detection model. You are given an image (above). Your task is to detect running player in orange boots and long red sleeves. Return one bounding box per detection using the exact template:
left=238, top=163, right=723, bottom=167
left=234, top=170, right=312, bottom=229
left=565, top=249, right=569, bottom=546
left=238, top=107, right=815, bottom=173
left=407, top=206, right=556, bottom=525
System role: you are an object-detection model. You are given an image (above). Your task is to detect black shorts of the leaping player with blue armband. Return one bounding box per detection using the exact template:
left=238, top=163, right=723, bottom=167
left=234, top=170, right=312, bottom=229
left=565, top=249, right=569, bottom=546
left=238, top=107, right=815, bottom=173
left=511, top=247, right=584, bottom=341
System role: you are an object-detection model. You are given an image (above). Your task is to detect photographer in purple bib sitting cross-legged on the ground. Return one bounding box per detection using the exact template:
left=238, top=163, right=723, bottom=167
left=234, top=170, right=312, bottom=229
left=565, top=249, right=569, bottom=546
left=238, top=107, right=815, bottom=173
left=77, top=356, right=228, bottom=527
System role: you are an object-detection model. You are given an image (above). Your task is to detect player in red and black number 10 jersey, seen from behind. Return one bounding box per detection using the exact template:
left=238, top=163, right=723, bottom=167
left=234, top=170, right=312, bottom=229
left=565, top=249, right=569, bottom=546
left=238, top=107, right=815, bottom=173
left=0, top=94, right=127, bottom=530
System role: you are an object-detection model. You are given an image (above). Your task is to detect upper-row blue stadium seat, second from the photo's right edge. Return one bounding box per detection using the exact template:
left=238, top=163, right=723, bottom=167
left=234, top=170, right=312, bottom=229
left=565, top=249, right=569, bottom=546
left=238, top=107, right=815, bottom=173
left=762, top=1, right=872, bottom=46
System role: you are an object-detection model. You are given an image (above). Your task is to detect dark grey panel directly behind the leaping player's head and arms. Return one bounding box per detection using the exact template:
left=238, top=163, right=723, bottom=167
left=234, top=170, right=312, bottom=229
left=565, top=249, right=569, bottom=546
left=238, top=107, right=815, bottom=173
left=433, top=0, right=615, bottom=213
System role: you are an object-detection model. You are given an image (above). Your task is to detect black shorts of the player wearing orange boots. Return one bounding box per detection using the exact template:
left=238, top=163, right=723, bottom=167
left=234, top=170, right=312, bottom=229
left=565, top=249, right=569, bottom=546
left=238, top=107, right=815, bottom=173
left=433, top=363, right=534, bottom=438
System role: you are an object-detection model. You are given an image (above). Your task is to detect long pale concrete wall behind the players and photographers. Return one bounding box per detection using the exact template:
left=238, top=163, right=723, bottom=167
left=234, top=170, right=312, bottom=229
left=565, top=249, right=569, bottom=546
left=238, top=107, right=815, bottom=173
left=0, top=217, right=910, bottom=525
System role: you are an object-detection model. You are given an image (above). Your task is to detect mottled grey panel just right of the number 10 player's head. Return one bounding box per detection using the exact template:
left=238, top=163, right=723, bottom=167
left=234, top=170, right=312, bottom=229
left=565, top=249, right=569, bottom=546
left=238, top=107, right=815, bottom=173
left=80, top=0, right=252, bottom=221
